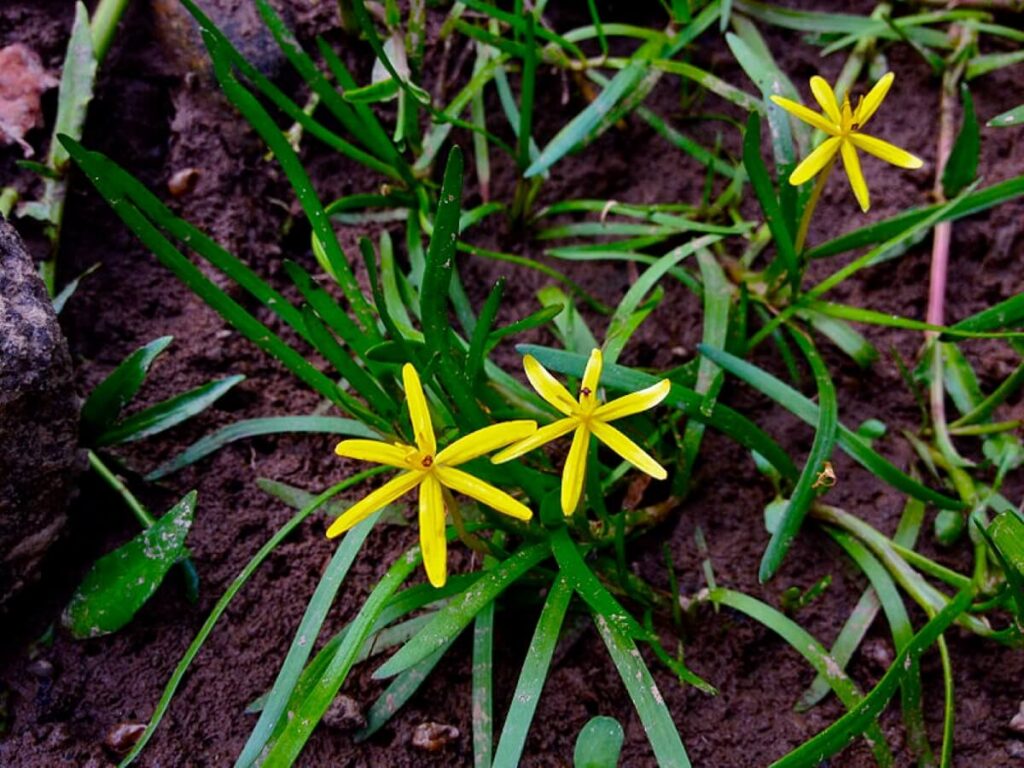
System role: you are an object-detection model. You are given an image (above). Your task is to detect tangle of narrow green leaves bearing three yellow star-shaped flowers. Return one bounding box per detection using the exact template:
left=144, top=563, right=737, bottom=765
left=44, top=0, right=1024, bottom=768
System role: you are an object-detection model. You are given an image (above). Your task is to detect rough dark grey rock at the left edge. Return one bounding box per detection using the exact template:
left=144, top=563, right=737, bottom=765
left=0, top=218, right=82, bottom=611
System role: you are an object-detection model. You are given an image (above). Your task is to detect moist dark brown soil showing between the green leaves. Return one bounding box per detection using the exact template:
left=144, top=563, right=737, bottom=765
left=0, top=0, right=1024, bottom=768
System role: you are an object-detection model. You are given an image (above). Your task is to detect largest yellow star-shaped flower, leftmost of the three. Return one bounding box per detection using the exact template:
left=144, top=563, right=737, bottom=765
left=327, top=364, right=537, bottom=587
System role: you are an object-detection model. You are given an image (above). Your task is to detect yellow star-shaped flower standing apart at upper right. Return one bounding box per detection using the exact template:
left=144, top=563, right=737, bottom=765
left=771, top=72, right=924, bottom=212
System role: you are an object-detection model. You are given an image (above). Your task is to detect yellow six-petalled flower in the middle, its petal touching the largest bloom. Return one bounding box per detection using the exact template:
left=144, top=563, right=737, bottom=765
left=492, top=349, right=672, bottom=515
